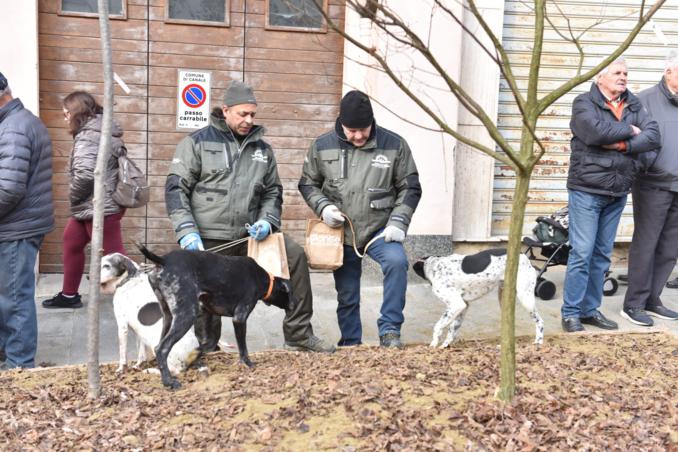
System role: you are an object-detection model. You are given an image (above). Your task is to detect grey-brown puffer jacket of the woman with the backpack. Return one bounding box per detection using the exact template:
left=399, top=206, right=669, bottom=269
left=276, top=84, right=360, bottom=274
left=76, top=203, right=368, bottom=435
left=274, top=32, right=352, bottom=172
left=69, top=114, right=127, bottom=221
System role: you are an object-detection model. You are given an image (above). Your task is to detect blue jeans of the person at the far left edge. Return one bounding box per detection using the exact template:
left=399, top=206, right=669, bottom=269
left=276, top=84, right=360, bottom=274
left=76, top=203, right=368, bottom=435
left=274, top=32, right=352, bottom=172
left=0, top=235, right=43, bottom=368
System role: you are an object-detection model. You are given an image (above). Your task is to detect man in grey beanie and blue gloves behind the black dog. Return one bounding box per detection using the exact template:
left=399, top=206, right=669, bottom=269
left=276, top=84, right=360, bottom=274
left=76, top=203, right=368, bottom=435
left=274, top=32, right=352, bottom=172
left=165, top=81, right=335, bottom=353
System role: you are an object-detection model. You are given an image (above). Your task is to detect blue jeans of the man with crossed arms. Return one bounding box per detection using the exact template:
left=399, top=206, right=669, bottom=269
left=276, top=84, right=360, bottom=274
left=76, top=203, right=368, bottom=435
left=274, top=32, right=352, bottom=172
left=561, top=190, right=626, bottom=318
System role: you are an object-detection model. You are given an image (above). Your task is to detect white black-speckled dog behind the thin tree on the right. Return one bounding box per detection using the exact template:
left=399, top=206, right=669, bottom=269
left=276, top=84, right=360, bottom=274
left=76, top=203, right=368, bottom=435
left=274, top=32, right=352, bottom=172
left=412, top=249, right=544, bottom=347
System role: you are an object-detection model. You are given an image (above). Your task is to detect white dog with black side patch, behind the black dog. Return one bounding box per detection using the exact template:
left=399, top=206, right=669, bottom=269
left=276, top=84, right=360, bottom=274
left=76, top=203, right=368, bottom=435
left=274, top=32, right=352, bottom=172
left=101, top=253, right=199, bottom=375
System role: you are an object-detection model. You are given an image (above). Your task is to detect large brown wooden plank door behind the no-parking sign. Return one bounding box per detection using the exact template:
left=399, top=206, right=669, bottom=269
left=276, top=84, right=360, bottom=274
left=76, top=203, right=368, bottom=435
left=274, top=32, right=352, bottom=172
left=39, top=0, right=343, bottom=271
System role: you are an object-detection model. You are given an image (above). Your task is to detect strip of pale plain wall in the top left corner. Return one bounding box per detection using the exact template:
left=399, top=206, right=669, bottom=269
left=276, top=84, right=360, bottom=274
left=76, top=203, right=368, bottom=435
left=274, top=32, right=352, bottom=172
left=0, top=0, right=39, bottom=114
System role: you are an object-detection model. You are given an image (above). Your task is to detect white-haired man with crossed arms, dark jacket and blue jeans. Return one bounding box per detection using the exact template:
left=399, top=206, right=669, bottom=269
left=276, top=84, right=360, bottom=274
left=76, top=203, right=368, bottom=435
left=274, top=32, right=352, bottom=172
left=561, top=59, right=660, bottom=332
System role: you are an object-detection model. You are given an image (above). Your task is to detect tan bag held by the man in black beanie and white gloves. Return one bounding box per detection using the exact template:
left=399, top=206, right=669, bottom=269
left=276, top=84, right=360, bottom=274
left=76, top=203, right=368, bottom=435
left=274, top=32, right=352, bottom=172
left=305, top=218, right=344, bottom=270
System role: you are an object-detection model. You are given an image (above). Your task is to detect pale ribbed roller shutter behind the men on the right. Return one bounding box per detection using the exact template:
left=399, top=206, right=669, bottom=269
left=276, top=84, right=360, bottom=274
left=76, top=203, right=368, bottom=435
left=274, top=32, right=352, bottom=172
left=492, top=0, right=678, bottom=241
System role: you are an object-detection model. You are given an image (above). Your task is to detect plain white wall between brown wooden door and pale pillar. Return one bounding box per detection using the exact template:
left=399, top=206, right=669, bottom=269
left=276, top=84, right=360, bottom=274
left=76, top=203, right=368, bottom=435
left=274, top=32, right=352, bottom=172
left=343, top=0, right=461, bottom=235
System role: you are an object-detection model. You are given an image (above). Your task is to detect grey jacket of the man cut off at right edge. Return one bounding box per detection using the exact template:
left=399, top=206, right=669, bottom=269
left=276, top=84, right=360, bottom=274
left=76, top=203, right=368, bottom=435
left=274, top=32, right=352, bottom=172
left=638, top=78, right=678, bottom=192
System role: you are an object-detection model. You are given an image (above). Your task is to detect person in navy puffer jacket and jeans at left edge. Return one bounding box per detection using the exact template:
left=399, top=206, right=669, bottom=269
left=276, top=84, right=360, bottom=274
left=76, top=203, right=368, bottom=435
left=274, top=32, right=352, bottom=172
left=0, top=73, right=54, bottom=369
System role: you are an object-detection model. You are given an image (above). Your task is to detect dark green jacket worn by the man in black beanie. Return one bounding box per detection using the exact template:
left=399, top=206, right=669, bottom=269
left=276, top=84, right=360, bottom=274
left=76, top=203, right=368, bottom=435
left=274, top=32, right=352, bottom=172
left=299, top=120, right=421, bottom=247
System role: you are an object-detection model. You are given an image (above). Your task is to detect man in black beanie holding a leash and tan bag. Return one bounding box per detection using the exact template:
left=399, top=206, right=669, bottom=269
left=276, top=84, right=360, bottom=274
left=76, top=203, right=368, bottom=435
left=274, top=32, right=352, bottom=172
left=299, top=90, right=421, bottom=348
